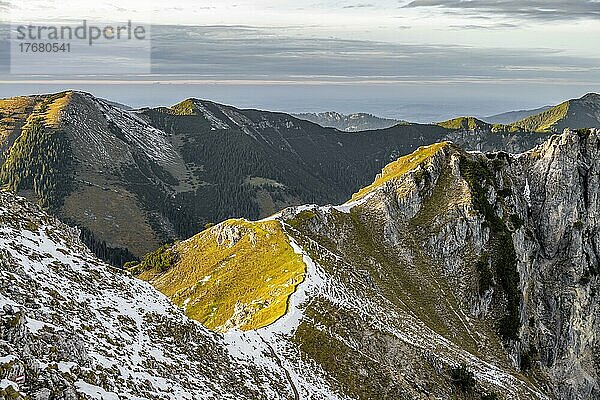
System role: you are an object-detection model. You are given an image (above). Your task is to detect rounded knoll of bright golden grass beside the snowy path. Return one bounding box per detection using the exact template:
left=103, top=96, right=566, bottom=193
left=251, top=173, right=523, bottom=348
left=140, top=220, right=306, bottom=332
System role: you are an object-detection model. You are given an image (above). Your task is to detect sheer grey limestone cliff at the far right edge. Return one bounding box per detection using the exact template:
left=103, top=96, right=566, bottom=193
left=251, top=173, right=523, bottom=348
left=516, top=131, right=600, bottom=399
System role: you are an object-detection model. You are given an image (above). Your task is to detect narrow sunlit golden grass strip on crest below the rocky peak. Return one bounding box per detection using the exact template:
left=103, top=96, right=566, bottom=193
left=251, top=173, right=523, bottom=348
left=351, top=142, right=449, bottom=201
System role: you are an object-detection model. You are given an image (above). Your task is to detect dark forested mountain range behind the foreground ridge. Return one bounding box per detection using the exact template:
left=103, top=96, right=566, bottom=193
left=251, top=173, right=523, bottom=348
left=5, top=91, right=597, bottom=266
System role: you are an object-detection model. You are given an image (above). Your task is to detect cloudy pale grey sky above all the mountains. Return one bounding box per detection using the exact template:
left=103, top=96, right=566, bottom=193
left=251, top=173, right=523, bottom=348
left=0, top=0, right=600, bottom=122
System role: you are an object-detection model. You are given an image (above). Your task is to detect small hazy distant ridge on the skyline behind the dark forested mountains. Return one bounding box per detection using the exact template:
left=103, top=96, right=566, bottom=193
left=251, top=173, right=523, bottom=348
left=292, top=111, right=406, bottom=132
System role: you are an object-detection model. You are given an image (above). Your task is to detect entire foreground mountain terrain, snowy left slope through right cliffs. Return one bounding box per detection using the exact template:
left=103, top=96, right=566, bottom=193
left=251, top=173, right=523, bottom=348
left=0, top=129, right=600, bottom=400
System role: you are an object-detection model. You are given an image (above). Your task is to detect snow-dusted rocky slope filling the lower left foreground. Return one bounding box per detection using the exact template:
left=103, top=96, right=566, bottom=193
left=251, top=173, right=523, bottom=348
left=0, top=192, right=342, bottom=400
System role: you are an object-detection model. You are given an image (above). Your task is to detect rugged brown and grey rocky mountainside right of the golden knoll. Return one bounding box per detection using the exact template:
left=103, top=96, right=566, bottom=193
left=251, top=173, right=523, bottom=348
left=276, top=130, right=600, bottom=399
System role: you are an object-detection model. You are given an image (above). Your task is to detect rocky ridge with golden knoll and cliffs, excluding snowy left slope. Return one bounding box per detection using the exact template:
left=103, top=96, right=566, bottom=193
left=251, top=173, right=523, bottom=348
left=131, top=130, right=600, bottom=399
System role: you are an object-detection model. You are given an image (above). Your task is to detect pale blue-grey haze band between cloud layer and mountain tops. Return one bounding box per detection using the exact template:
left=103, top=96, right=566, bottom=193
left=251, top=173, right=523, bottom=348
left=0, top=84, right=600, bottom=123
